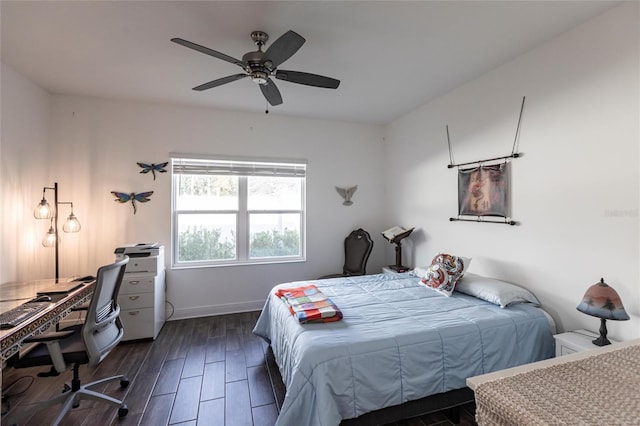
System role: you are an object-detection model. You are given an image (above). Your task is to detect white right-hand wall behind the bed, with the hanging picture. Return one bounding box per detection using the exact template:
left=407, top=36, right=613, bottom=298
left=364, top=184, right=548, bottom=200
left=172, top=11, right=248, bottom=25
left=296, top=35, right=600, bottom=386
left=385, top=2, right=640, bottom=338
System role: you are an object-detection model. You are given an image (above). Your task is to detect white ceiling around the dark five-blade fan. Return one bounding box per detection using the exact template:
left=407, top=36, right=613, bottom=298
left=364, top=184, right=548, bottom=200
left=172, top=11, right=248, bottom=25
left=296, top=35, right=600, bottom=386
left=0, top=0, right=616, bottom=124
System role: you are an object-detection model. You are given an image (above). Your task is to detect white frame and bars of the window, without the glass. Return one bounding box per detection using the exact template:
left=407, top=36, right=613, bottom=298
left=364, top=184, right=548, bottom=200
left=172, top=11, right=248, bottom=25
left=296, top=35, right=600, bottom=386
left=170, top=153, right=307, bottom=269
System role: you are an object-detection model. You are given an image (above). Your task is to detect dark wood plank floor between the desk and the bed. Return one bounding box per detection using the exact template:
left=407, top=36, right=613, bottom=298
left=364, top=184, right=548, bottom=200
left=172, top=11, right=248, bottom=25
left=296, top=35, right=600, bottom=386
left=2, top=312, right=475, bottom=426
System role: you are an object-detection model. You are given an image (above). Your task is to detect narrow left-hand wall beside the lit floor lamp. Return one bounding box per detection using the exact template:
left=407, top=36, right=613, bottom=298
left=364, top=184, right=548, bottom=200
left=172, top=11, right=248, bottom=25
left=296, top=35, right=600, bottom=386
left=0, top=64, right=55, bottom=283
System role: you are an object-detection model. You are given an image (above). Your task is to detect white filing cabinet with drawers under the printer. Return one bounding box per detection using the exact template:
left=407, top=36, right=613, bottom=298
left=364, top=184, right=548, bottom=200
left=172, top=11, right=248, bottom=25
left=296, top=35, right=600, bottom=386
left=118, top=246, right=166, bottom=340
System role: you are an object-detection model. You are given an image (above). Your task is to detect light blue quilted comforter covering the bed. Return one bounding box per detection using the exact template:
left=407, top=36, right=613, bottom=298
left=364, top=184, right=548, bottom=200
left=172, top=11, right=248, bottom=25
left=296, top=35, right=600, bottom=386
left=253, top=275, right=554, bottom=426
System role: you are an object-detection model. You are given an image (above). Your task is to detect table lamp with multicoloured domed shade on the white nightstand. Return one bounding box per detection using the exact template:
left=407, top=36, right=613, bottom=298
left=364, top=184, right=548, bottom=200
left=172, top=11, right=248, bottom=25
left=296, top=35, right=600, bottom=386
left=576, top=278, right=629, bottom=346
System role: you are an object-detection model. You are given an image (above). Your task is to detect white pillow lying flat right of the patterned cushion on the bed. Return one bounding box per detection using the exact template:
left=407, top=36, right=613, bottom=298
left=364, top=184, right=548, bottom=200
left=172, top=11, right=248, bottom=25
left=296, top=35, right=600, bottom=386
left=455, top=273, right=540, bottom=308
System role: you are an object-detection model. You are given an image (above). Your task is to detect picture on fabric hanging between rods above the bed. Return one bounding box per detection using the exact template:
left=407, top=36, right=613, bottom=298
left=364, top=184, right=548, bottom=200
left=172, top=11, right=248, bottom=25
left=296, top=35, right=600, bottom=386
left=458, top=162, right=510, bottom=218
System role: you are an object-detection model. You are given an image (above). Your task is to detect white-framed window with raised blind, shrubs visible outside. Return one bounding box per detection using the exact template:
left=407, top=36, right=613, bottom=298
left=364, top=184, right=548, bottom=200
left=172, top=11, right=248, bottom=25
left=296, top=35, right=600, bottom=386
left=172, top=156, right=306, bottom=267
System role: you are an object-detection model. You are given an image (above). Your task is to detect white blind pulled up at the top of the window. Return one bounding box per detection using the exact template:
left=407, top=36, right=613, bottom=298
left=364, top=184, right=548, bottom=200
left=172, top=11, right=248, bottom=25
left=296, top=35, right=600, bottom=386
left=172, top=158, right=307, bottom=177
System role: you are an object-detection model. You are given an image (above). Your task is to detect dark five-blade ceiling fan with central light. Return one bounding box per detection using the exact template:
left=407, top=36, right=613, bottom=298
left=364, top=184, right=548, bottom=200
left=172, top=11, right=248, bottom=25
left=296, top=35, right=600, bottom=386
left=171, top=31, right=340, bottom=106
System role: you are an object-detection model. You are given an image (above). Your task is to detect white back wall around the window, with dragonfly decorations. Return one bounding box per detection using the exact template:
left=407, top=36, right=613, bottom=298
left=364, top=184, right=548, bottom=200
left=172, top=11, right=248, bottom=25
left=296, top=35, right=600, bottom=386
left=43, top=96, right=385, bottom=318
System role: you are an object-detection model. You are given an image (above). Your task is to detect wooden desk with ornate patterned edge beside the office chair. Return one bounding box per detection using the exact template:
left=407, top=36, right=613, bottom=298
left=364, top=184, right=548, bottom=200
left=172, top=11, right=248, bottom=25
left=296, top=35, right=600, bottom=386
left=0, top=278, right=95, bottom=365
